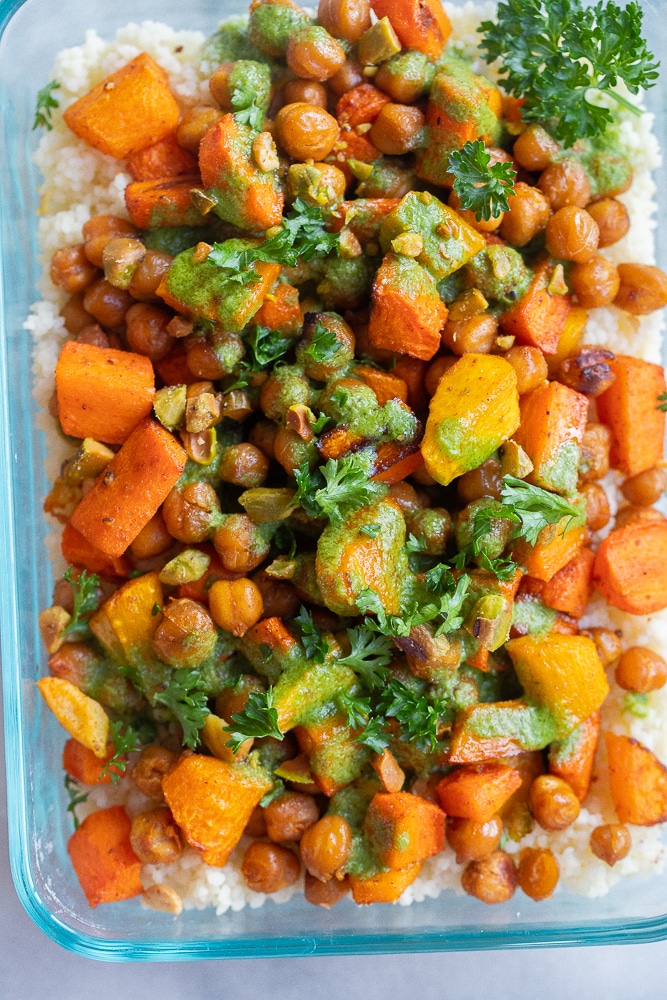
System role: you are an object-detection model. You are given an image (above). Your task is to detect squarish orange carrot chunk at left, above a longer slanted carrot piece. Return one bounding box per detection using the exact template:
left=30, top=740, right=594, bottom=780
left=56, top=340, right=155, bottom=444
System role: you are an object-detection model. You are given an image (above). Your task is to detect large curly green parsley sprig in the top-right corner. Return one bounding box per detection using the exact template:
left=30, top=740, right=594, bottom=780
left=479, top=0, right=659, bottom=146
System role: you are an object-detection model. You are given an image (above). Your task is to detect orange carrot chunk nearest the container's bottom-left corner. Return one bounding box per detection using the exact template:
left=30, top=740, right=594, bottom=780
left=67, top=806, right=143, bottom=907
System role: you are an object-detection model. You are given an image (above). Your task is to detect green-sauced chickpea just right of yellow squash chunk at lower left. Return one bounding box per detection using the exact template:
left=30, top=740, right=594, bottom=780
left=151, top=597, right=218, bottom=668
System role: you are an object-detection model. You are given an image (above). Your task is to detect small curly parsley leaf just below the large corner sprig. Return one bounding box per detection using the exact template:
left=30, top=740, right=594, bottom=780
left=449, top=139, right=516, bottom=222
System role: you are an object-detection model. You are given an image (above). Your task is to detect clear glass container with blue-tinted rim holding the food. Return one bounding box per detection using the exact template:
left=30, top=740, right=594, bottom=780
left=0, top=0, right=667, bottom=961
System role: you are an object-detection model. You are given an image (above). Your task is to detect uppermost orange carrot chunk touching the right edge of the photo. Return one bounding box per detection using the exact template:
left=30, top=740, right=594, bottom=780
left=596, top=354, right=667, bottom=476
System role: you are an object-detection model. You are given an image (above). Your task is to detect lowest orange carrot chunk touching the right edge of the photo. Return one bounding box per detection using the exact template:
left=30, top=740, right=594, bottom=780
left=604, top=733, right=667, bottom=826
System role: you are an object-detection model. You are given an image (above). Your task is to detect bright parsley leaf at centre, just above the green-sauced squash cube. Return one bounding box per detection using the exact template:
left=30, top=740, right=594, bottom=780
left=294, top=455, right=387, bottom=524
